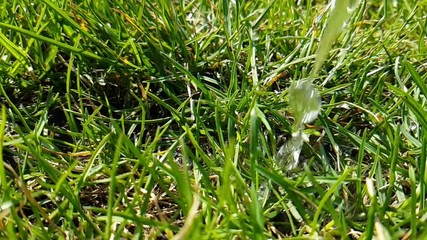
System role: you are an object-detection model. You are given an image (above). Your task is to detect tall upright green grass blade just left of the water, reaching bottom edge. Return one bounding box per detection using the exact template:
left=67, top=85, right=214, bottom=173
left=249, top=105, right=264, bottom=239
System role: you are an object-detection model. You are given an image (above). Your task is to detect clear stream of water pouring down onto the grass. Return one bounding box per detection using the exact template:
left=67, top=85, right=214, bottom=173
left=276, top=0, right=359, bottom=171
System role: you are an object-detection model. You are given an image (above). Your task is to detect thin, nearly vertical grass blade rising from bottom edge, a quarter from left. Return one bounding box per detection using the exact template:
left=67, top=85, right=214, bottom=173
left=105, top=130, right=124, bottom=239
